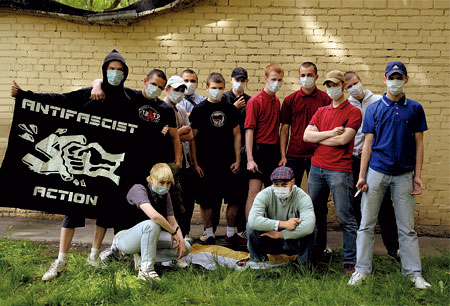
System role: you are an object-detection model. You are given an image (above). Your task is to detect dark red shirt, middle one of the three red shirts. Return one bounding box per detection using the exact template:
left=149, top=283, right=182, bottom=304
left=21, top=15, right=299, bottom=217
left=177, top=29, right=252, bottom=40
left=281, top=88, right=332, bottom=158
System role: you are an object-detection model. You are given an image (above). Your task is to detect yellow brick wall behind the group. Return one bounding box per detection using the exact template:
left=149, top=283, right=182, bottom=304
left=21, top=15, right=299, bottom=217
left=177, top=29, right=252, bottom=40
left=0, top=0, right=450, bottom=234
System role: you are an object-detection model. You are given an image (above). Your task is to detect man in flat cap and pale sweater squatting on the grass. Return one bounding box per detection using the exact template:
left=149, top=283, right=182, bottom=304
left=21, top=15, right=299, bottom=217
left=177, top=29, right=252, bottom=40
left=247, top=166, right=316, bottom=269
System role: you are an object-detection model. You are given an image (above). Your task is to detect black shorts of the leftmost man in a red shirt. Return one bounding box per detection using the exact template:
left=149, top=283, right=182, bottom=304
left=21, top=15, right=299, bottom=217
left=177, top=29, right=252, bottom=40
left=248, top=143, right=281, bottom=187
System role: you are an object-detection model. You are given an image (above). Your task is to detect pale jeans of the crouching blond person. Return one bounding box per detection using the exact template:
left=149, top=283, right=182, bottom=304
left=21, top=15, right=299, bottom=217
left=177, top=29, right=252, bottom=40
left=115, top=219, right=191, bottom=271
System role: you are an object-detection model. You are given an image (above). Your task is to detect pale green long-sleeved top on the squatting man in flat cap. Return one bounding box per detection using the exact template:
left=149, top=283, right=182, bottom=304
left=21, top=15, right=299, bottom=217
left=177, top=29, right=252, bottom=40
left=248, top=185, right=316, bottom=239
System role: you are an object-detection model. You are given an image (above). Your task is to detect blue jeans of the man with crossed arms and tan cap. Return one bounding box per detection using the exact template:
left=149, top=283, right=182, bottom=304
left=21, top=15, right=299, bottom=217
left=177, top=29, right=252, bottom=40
left=308, top=166, right=358, bottom=264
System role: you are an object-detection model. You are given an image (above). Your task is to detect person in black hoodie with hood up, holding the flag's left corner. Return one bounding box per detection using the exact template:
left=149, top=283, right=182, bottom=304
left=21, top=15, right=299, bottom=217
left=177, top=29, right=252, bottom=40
left=11, top=50, right=137, bottom=281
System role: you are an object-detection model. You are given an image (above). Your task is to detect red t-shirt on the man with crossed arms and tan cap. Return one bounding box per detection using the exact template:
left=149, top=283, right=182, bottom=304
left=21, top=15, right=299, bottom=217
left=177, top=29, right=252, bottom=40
left=309, top=100, right=362, bottom=173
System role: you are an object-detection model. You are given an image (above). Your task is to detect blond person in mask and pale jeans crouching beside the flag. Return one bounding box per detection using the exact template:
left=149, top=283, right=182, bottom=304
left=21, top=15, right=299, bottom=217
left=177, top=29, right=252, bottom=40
left=112, top=163, right=191, bottom=280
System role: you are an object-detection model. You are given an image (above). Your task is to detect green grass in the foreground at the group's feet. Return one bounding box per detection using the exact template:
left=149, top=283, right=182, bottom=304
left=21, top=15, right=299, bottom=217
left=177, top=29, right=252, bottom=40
left=0, top=238, right=450, bottom=306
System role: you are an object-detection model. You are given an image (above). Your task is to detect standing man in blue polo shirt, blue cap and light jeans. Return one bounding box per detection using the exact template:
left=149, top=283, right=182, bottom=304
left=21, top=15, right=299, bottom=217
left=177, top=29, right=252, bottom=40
left=348, top=61, right=431, bottom=289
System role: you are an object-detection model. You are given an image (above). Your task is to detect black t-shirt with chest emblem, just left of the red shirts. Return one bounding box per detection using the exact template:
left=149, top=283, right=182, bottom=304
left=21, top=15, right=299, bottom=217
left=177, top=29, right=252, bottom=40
left=189, top=99, right=239, bottom=167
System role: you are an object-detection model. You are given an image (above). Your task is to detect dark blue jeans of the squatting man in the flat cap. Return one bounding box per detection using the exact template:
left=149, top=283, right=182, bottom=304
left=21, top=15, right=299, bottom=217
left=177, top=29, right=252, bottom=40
left=247, top=225, right=314, bottom=268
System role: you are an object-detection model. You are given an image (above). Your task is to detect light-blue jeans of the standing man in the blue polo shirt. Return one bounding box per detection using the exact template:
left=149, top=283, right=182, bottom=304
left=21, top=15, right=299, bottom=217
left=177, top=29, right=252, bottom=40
left=355, top=168, right=422, bottom=275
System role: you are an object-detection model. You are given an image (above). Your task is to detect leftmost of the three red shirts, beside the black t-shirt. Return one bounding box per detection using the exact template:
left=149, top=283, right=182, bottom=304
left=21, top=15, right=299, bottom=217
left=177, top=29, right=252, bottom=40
left=244, top=89, right=280, bottom=144
